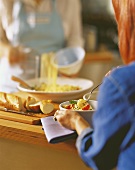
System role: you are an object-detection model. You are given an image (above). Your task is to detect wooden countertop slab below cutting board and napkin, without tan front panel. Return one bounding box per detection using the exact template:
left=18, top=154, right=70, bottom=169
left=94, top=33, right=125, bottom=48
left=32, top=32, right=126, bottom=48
left=0, top=112, right=77, bottom=154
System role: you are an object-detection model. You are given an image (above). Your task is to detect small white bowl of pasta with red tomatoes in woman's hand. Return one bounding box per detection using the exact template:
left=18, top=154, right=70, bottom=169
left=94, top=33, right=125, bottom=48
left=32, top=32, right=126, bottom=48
left=59, top=99, right=97, bottom=125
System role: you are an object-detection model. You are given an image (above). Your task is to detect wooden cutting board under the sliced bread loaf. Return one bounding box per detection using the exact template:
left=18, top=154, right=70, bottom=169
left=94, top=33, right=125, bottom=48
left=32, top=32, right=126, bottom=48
left=0, top=92, right=59, bottom=125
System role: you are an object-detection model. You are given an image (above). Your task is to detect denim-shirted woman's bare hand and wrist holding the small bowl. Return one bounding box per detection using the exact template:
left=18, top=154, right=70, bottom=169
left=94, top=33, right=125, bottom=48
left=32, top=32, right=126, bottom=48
left=54, top=110, right=90, bottom=135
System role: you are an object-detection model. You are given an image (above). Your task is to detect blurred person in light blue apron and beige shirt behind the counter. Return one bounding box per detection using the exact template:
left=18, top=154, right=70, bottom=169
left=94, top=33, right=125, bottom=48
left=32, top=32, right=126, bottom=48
left=0, top=0, right=84, bottom=91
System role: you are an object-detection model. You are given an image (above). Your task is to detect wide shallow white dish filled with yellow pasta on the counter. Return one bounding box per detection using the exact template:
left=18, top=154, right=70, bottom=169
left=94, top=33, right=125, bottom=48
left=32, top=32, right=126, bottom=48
left=17, top=77, right=93, bottom=103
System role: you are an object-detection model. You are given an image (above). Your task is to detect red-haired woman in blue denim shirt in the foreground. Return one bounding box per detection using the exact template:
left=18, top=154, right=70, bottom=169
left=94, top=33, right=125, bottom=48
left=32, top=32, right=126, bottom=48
left=54, top=0, right=135, bottom=170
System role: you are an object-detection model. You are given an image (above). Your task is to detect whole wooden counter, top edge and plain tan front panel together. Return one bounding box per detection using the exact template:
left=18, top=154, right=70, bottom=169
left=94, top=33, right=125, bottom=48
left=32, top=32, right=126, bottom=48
left=0, top=93, right=90, bottom=170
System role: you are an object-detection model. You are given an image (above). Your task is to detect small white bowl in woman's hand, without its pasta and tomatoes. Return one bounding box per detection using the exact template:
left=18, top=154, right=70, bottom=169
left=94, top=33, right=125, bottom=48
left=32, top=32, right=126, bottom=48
left=59, top=100, right=98, bottom=125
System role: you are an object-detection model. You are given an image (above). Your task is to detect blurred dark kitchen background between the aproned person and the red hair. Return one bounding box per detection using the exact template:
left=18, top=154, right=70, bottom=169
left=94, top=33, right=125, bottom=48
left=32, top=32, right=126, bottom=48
left=79, top=0, right=123, bottom=85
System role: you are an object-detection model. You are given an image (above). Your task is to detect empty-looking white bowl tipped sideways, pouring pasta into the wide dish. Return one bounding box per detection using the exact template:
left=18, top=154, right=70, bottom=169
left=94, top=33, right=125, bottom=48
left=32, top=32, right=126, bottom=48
left=52, top=47, right=85, bottom=76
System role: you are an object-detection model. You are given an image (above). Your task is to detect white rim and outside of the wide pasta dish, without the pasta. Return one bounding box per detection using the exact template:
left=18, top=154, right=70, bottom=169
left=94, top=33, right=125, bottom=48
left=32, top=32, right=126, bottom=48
left=17, top=77, right=93, bottom=103
